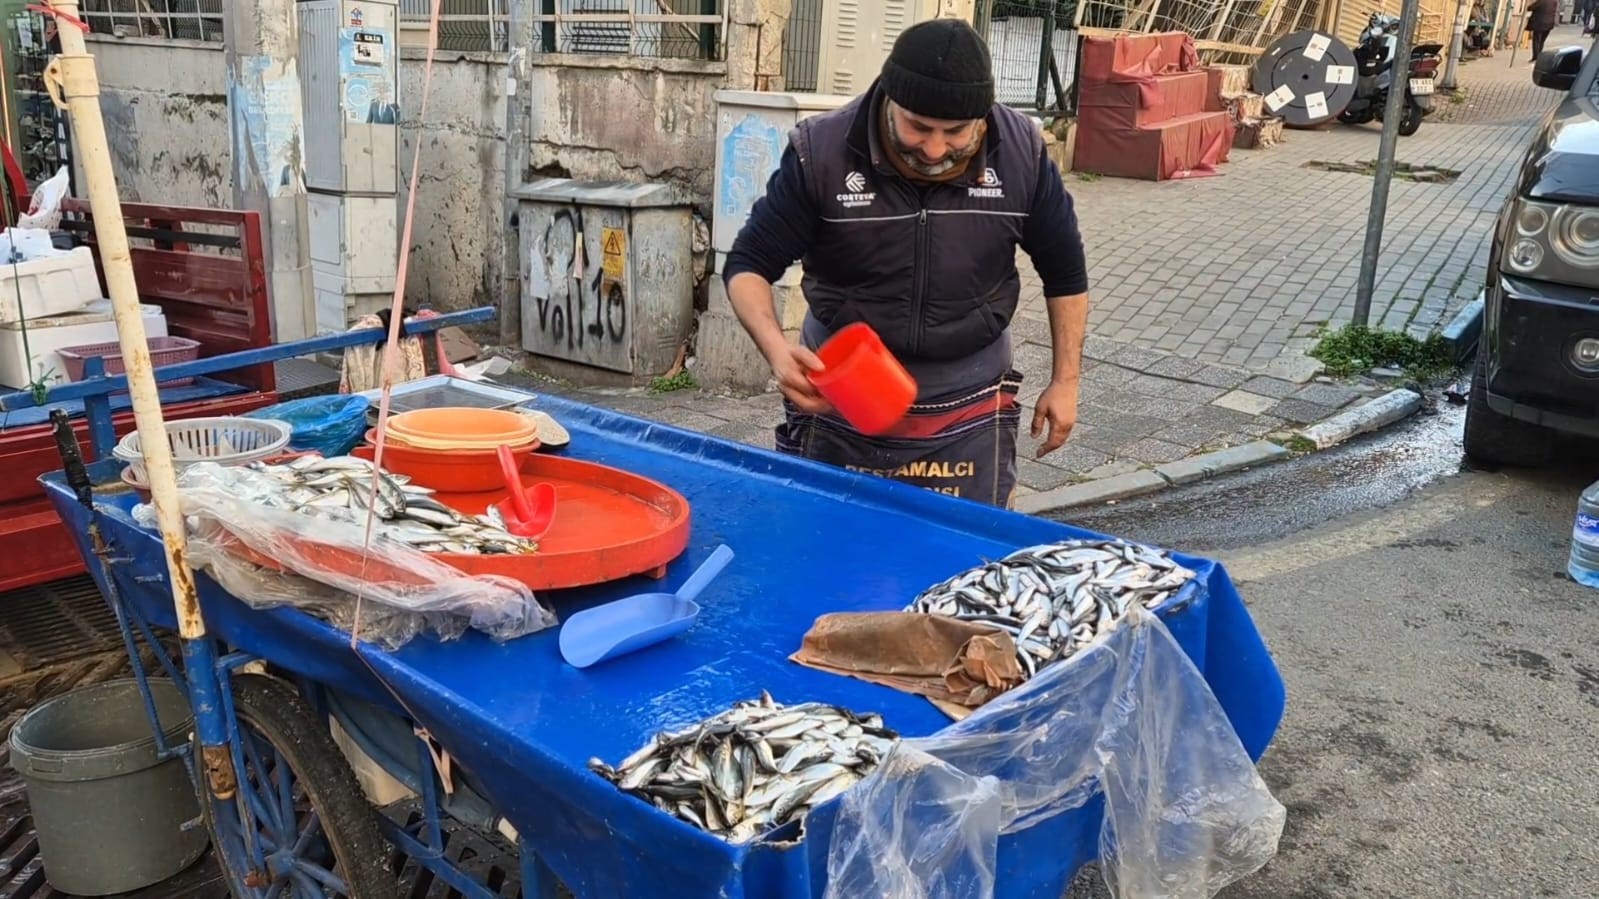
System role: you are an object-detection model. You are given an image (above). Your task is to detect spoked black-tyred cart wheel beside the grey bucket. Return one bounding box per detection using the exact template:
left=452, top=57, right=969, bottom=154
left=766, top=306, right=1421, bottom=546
left=200, top=675, right=398, bottom=899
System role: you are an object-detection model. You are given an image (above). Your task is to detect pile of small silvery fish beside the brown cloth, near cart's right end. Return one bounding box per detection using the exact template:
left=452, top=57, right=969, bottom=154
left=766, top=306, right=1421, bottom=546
left=905, top=541, right=1194, bottom=677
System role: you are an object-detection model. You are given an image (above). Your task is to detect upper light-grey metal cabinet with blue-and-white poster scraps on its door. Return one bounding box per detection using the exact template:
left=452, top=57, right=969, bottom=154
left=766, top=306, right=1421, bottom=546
left=299, top=0, right=400, bottom=194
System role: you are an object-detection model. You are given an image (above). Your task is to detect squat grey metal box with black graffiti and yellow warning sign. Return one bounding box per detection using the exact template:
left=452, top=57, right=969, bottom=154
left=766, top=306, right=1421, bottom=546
left=515, top=178, right=694, bottom=376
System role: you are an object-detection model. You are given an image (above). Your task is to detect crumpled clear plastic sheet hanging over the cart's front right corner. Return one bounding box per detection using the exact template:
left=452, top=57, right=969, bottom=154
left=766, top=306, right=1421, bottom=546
left=827, top=606, right=1286, bottom=899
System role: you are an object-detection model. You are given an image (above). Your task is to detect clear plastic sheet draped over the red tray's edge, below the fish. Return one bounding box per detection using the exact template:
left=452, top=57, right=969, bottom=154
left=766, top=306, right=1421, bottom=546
left=134, top=462, right=556, bottom=649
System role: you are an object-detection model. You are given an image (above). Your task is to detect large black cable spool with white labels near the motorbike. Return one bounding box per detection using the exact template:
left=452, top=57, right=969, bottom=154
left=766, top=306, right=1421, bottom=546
left=1254, top=30, right=1356, bottom=128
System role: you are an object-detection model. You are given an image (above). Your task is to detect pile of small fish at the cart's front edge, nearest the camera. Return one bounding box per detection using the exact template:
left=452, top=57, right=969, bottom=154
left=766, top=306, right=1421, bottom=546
left=588, top=689, right=899, bottom=843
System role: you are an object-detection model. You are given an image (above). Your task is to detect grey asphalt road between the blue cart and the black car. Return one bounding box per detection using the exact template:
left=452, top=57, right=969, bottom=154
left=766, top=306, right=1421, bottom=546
left=1071, top=414, right=1599, bottom=899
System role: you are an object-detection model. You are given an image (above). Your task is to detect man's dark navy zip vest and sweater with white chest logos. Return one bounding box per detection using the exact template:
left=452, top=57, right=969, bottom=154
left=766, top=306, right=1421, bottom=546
left=723, top=83, right=1087, bottom=360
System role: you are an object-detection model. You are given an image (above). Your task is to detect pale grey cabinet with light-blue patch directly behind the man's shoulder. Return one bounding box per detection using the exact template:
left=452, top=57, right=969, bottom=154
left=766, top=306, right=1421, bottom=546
left=710, top=90, right=851, bottom=274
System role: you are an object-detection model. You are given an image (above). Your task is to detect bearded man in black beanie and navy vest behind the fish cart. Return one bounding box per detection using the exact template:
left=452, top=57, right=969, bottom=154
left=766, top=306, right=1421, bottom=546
left=723, top=19, right=1087, bottom=505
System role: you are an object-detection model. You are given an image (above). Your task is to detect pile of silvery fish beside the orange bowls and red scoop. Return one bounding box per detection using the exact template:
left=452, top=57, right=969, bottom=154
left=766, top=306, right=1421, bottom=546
left=231, top=454, right=539, bottom=555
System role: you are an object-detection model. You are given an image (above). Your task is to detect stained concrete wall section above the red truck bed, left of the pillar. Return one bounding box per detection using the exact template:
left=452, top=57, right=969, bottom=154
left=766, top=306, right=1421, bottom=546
left=78, top=35, right=233, bottom=208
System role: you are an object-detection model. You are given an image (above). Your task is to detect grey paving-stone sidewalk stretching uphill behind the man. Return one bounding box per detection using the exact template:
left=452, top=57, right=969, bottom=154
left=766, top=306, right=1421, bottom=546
left=508, top=29, right=1580, bottom=499
